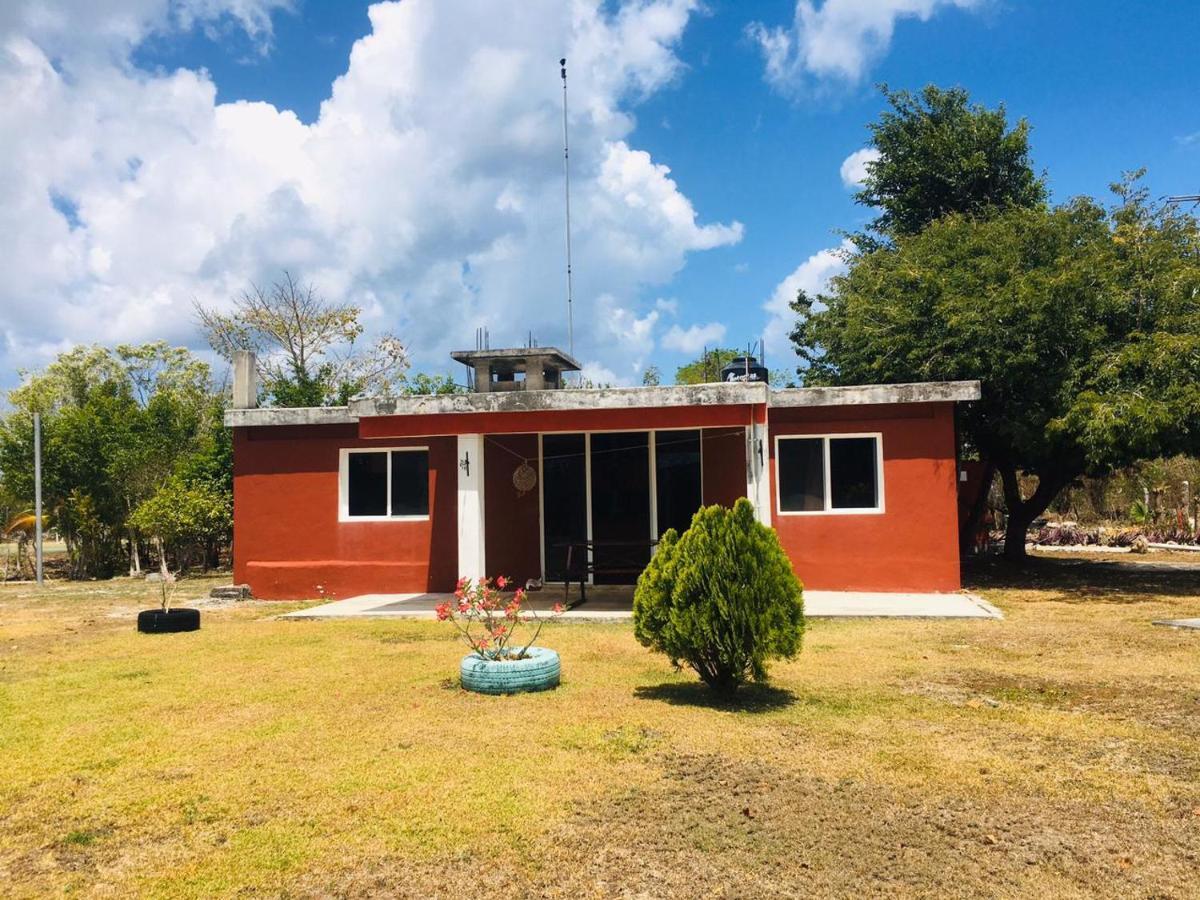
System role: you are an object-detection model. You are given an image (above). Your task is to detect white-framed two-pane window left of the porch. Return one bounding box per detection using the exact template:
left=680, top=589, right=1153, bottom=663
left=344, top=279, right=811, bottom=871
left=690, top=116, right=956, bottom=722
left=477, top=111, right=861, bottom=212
left=341, top=446, right=430, bottom=520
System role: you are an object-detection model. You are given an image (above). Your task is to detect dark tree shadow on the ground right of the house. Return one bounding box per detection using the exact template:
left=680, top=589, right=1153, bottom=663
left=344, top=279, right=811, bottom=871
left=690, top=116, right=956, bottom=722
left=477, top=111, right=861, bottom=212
left=962, top=557, right=1200, bottom=602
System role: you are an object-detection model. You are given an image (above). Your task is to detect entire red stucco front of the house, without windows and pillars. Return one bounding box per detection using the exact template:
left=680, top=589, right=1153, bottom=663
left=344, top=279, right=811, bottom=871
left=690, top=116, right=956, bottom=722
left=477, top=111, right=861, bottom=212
left=234, top=403, right=960, bottom=599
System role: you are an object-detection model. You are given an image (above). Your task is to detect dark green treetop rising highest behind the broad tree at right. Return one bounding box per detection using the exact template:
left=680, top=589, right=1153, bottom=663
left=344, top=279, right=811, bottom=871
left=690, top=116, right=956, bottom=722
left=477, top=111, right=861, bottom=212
left=854, top=85, right=1046, bottom=248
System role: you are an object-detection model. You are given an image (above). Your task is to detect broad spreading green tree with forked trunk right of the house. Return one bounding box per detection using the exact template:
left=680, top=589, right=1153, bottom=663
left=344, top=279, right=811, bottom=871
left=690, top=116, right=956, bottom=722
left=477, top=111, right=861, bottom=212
left=792, top=178, right=1200, bottom=558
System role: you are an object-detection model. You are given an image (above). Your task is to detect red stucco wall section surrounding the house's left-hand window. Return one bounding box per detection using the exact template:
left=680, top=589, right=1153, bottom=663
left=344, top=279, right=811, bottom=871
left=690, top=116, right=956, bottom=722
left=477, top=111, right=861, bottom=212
left=233, top=425, right=458, bottom=600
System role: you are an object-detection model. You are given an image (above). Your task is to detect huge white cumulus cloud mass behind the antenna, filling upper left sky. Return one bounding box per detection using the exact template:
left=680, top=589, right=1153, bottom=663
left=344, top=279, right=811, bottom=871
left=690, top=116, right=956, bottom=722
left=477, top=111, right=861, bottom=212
left=0, top=0, right=742, bottom=388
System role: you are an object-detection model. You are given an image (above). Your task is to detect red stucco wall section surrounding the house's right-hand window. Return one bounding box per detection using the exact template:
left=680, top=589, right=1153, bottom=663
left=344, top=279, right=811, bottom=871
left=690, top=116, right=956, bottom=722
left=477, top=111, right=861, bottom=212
left=769, top=403, right=961, bottom=592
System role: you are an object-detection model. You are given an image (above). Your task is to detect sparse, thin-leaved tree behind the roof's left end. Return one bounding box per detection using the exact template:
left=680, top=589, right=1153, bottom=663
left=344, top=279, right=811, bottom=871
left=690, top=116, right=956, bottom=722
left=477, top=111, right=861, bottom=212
left=196, top=272, right=408, bottom=407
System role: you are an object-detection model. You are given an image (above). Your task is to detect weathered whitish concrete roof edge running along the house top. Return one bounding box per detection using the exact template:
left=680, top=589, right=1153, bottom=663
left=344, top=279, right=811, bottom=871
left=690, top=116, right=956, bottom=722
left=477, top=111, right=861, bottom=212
left=224, top=382, right=980, bottom=427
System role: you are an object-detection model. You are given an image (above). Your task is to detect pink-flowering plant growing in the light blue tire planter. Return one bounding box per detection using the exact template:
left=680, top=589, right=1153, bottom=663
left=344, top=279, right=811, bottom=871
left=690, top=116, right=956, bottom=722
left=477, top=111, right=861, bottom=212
left=437, top=575, right=563, bottom=660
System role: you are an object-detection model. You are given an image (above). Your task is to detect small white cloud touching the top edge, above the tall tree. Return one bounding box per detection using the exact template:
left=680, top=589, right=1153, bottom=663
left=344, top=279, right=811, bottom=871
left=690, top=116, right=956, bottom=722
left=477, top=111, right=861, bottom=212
left=748, top=0, right=985, bottom=91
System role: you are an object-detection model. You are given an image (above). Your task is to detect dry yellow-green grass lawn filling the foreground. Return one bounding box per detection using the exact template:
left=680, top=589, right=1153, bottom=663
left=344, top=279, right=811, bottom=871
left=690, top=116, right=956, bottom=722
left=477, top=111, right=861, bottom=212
left=0, top=559, right=1200, bottom=898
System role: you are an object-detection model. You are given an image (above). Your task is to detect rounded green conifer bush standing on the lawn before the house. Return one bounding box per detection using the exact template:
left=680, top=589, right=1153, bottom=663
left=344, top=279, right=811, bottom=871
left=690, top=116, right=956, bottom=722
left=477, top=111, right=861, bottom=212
left=634, top=498, right=804, bottom=692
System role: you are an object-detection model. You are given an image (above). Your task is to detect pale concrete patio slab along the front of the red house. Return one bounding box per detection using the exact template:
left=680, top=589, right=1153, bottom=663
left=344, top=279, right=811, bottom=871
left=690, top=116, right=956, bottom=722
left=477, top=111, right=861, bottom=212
left=280, top=590, right=1004, bottom=619
